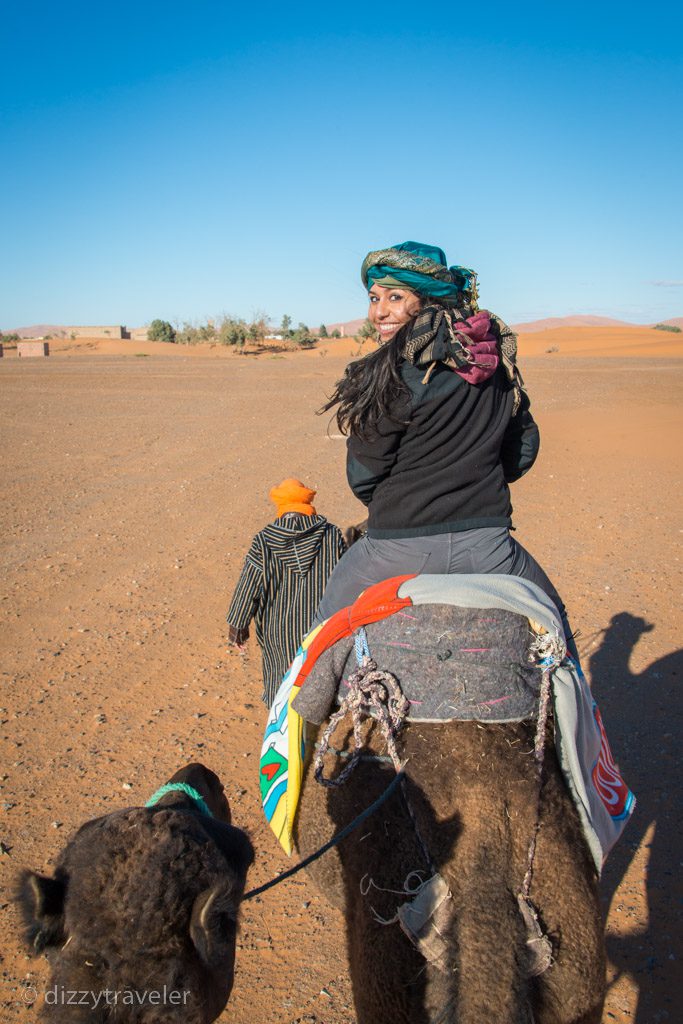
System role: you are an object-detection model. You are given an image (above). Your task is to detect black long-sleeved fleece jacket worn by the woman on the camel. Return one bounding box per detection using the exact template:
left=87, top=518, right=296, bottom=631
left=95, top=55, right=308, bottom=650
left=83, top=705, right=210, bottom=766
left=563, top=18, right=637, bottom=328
left=346, top=361, right=539, bottom=538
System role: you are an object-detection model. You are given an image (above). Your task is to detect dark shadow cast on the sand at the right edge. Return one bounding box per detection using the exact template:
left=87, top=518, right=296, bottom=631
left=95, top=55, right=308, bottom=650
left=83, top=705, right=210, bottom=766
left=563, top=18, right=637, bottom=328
left=588, top=611, right=683, bottom=1024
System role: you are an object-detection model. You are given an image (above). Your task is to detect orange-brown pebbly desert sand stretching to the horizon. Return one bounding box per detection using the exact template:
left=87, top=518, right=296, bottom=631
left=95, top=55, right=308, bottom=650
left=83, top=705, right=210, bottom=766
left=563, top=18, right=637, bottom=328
left=0, top=328, right=683, bottom=1024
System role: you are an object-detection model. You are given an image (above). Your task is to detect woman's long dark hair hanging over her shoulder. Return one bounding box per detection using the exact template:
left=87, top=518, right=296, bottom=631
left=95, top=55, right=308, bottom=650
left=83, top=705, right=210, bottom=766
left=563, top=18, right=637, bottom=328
left=318, top=325, right=408, bottom=439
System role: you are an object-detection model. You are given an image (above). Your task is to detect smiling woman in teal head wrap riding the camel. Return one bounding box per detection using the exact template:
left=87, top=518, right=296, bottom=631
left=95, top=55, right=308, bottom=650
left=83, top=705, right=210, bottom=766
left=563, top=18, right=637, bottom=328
left=315, top=242, right=569, bottom=655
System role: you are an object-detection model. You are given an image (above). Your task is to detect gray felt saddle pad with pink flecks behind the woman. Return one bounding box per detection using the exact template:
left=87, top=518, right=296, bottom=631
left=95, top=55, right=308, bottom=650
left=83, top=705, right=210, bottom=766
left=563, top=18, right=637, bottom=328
left=294, top=604, right=541, bottom=724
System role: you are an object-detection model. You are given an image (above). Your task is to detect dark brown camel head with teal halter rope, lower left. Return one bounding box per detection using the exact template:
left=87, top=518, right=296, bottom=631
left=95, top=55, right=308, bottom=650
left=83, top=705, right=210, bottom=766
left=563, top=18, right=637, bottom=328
left=16, top=764, right=254, bottom=1024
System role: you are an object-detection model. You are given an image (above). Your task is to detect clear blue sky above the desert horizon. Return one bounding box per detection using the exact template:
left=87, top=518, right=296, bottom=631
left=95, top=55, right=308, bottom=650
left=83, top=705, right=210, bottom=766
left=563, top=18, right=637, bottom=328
left=0, top=0, right=683, bottom=330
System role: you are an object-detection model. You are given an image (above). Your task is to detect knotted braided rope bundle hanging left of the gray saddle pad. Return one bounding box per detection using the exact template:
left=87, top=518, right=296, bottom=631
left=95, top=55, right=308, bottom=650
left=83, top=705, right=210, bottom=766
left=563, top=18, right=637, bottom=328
left=313, top=654, right=410, bottom=786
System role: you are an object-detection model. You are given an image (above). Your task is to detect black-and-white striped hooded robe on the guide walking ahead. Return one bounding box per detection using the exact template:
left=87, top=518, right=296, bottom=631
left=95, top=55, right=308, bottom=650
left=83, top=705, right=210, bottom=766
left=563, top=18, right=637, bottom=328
left=227, top=512, right=344, bottom=708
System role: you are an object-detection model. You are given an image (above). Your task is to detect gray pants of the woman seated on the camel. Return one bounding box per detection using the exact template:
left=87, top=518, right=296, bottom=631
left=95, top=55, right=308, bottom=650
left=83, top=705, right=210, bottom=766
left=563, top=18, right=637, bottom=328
left=311, top=526, right=578, bottom=657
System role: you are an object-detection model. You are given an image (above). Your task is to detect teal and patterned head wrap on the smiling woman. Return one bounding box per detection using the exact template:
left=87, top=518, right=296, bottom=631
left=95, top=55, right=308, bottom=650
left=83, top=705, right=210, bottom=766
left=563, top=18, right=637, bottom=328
left=360, top=242, right=477, bottom=309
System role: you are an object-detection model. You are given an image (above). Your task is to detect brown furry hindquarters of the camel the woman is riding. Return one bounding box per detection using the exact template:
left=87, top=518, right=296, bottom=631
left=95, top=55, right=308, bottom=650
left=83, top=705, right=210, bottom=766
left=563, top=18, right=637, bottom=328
left=297, top=722, right=605, bottom=1024
